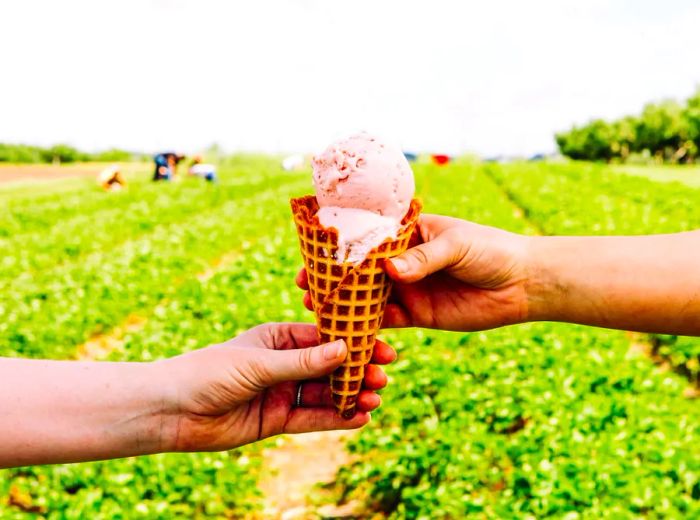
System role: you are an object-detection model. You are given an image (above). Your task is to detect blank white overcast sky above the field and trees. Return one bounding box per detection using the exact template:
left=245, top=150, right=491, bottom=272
left=0, top=0, right=700, bottom=155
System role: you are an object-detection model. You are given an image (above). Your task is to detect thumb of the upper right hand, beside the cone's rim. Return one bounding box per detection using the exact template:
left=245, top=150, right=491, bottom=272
left=386, top=234, right=455, bottom=283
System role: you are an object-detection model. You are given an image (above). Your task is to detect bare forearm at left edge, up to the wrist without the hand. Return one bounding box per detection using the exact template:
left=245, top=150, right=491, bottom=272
left=0, top=358, right=174, bottom=468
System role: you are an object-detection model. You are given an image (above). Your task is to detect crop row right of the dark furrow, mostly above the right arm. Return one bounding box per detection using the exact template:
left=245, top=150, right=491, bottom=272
left=486, top=163, right=700, bottom=388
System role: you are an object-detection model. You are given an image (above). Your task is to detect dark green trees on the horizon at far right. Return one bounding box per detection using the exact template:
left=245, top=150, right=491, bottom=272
left=556, top=89, right=700, bottom=163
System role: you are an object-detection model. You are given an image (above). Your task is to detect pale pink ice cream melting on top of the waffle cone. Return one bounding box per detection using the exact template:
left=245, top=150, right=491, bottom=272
left=312, top=133, right=415, bottom=263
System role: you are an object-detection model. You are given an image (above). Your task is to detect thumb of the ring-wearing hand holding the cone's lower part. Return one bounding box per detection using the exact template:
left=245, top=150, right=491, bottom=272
left=258, top=340, right=347, bottom=386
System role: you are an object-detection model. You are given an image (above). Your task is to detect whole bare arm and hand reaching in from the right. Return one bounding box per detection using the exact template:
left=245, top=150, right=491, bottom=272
left=306, top=215, right=700, bottom=336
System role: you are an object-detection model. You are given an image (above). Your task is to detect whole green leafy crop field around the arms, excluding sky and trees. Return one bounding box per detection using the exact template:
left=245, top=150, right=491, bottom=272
left=0, top=157, right=700, bottom=519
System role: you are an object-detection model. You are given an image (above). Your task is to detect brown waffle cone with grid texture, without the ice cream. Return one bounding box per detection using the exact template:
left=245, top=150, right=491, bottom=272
left=291, top=195, right=421, bottom=418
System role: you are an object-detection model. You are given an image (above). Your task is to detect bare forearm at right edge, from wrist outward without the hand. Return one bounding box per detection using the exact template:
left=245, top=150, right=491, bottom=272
left=527, top=231, right=700, bottom=335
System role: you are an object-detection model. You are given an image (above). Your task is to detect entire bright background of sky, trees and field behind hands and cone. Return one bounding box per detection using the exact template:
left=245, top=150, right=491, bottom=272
left=0, top=0, right=700, bottom=520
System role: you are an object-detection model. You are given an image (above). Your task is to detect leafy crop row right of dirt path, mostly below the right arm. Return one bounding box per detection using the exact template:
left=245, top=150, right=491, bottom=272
left=330, top=161, right=700, bottom=518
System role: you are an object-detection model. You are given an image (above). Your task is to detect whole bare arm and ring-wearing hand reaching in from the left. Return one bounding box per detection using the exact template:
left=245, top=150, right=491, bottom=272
left=0, top=323, right=396, bottom=468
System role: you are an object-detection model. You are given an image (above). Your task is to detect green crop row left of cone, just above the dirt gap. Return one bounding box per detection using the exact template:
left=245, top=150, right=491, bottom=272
left=0, top=167, right=302, bottom=358
